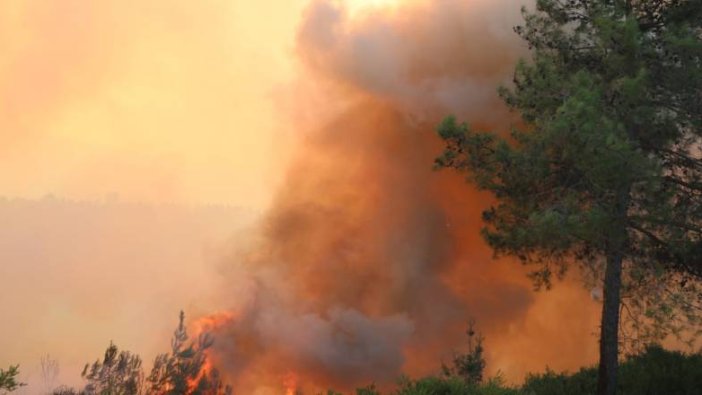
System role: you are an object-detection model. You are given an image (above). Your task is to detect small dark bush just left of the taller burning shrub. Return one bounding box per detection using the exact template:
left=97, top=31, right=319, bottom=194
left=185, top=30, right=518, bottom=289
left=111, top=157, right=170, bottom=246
left=81, top=342, right=144, bottom=395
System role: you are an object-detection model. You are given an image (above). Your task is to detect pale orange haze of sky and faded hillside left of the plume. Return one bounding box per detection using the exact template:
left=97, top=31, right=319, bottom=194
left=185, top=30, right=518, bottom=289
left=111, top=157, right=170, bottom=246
left=0, top=0, right=428, bottom=393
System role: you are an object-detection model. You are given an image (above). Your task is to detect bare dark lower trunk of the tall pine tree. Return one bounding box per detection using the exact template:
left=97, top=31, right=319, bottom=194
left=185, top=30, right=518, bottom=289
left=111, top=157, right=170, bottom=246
left=597, top=252, right=622, bottom=395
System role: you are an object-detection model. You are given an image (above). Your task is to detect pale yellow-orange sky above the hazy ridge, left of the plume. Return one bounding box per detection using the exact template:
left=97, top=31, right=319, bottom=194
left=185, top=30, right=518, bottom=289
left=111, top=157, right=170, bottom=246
left=0, top=0, right=316, bottom=208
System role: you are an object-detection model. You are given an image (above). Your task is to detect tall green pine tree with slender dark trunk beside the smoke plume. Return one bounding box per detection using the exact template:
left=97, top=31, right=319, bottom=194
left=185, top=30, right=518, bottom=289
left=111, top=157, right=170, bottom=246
left=437, top=0, right=702, bottom=394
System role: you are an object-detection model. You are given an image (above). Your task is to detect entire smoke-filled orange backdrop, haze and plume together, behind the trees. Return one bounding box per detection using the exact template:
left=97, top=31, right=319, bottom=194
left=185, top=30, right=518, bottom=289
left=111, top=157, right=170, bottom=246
left=0, top=0, right=599, bottom=394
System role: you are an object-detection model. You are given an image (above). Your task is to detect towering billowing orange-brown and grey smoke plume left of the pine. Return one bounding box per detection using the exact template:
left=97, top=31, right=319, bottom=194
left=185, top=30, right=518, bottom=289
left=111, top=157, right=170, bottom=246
left=201, top=0, right=597, bottom=393
